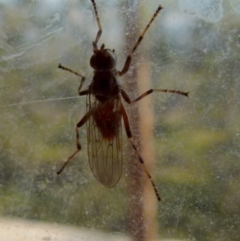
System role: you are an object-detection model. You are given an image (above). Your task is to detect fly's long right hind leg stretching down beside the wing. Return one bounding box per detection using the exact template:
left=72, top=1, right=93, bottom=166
left=121, top=103, right=161, bottom=201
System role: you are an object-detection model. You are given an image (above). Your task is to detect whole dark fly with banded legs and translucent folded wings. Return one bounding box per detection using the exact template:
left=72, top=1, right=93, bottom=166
left=57, top=0, right=188, bottom=201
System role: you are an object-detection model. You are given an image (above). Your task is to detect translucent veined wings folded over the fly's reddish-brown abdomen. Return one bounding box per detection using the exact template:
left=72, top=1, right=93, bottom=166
left=87, top=95, right=122, bottom=187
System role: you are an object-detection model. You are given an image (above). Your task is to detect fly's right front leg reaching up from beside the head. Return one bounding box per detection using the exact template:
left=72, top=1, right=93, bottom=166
left=118, top=5, right=163, bottom=76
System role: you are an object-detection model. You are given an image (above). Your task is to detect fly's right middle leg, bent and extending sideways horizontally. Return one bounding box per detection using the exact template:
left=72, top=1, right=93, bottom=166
left=121, top=89, right=189, bottom=104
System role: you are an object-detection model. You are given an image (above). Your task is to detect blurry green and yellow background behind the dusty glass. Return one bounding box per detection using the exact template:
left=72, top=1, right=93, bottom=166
left=0, top=0, right=240, bottom=241
